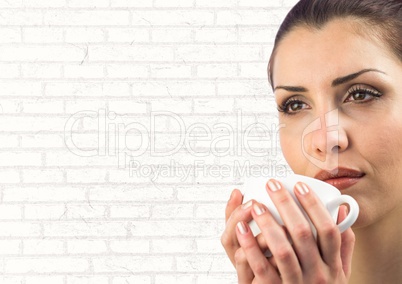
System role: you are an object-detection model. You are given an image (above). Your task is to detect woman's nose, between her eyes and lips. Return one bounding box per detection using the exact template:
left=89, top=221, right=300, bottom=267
left=302, top=109, right=349, bottom=169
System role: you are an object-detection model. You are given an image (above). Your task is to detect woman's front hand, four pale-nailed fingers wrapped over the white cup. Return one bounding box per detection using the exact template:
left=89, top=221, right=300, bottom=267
left=232, top=180, right=354, bottom=284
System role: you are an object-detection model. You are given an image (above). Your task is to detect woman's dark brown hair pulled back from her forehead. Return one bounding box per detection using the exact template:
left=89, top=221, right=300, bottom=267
left=268, top=0, right=402, bottom=87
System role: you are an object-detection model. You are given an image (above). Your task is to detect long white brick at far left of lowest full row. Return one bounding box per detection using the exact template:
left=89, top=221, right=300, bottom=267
left=5, top=257, right=89, bottom=272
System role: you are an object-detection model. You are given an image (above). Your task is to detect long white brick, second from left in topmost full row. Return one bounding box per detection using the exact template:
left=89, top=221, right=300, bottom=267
left=43, top=10, right=129, bottom=26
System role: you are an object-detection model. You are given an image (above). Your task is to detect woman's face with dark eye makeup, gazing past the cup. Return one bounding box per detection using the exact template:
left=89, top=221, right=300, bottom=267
left=273, top=20, right=402, bottom=227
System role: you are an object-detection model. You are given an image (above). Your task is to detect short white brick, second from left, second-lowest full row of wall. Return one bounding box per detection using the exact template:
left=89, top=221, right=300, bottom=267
left=23, top=239, right=64, bottom=255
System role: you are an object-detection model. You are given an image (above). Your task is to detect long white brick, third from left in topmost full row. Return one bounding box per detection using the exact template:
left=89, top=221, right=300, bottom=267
left=131, top=9, right=214, bottom=26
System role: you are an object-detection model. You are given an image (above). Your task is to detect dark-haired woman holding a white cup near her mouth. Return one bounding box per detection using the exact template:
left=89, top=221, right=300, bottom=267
left=222, top=0, right=402, bottom=283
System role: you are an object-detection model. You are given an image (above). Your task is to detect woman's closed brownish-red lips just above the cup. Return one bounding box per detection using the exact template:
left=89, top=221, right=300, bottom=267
left=314, top=168, right=365, bottom=190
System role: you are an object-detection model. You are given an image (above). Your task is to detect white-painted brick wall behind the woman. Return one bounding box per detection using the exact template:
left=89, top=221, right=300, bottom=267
left=0, top=0, right=296, bottom=284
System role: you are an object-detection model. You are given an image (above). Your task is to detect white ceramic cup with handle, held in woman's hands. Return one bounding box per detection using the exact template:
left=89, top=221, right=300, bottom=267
left=243, top=174, right=359, bottom=240
